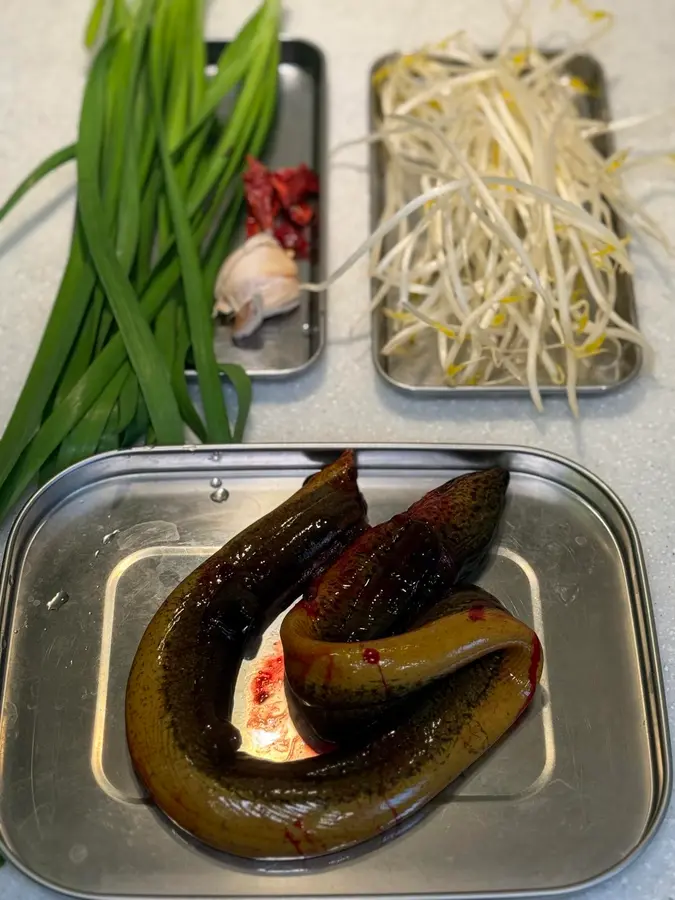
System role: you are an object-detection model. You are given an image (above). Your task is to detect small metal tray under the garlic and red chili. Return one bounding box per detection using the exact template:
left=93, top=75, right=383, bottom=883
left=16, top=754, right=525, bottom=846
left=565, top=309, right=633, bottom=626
left=188, top=40, right=328, bottom=383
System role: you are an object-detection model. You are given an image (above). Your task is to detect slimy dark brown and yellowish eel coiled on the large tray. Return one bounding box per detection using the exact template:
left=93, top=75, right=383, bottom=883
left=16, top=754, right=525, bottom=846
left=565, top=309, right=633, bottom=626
left=126, top=455, right=542, bottom=858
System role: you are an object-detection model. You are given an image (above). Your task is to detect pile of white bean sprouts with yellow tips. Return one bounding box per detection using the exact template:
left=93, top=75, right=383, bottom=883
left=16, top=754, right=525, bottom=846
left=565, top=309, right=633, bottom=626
left=308, top=2, right=669, bottom=415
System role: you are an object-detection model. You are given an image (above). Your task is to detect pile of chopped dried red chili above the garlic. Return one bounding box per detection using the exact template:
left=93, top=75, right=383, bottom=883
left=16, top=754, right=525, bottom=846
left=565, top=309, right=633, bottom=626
left=244, top=156, right=319, bottom=259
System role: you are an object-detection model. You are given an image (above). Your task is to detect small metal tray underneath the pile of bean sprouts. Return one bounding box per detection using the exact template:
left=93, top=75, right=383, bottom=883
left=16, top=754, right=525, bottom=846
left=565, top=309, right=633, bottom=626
left=370, top=53, right=643, bottom=397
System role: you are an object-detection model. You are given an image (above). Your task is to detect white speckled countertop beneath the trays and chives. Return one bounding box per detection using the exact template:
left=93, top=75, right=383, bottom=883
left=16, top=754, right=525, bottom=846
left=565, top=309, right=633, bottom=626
left=0, top=0, right=675, bottom=900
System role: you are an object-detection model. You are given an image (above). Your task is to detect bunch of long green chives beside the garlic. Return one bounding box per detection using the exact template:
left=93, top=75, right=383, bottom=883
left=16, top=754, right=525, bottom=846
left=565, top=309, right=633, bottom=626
left=0, top=0, right=280, bottom=513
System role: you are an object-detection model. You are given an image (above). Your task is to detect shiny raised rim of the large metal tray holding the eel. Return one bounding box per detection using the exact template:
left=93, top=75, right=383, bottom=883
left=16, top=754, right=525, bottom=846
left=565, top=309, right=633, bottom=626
left=0, top=442, right=673, bottom=900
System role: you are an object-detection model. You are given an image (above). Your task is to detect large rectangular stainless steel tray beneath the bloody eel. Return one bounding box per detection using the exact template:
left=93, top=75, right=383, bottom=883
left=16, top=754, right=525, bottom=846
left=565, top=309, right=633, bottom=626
left=0, top=445, right=671, bottom=898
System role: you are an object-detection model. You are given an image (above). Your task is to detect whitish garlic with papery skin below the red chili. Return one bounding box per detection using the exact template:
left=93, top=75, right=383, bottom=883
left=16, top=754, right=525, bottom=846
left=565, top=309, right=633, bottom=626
left=214, top=233, right=300, bottom=338
